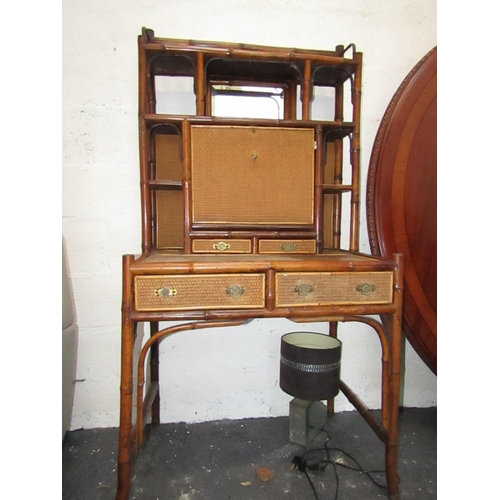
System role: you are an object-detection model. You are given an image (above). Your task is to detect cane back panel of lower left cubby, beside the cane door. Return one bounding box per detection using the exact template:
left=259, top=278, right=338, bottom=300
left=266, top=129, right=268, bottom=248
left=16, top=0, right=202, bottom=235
left=155, top=191, right=184, bottom=248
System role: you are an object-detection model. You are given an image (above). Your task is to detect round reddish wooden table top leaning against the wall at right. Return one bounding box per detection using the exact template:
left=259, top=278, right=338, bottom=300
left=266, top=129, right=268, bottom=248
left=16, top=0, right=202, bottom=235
left=367, top=47, right=437, bottom=373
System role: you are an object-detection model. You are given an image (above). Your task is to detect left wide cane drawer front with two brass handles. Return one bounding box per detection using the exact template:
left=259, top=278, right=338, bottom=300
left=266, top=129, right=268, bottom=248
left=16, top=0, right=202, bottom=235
left=134, top=274, right=265, bottom=311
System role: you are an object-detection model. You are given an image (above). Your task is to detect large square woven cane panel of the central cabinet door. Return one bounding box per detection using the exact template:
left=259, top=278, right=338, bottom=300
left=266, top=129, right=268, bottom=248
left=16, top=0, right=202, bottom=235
left=191, top=126, right=314, bottom=225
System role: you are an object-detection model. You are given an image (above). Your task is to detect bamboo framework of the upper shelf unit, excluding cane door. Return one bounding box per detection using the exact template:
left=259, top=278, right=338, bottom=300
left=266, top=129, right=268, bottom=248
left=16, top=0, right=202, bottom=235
left=138, top=29, right=362, bottom=253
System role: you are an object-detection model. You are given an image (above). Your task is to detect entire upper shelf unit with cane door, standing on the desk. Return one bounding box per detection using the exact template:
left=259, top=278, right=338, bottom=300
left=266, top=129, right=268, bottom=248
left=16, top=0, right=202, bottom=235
left=138, top=28, right=362, bottom=253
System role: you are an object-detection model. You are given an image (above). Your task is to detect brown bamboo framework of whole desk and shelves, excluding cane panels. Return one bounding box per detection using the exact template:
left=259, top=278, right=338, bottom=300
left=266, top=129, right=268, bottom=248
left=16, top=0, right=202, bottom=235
left=116, top=29, right=403, bottom=500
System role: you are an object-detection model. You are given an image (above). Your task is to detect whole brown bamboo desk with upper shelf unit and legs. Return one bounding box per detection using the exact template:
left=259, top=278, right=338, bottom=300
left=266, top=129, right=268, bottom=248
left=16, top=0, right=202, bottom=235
left=116, top=29, right=403, bottom=500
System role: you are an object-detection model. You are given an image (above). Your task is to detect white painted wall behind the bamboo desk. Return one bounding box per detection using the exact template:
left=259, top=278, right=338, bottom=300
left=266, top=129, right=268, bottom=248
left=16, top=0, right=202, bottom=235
left=62, top=0, right=437, bottom=429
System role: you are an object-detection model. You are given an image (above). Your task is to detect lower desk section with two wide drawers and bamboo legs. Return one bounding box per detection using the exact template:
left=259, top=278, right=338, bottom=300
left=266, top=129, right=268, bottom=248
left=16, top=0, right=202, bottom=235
left=116, top=251, right=403, bottom=500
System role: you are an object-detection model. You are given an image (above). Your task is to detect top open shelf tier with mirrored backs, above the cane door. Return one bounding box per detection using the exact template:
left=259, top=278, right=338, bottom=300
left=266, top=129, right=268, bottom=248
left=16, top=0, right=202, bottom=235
left=140, top=28, right=362, bottom=127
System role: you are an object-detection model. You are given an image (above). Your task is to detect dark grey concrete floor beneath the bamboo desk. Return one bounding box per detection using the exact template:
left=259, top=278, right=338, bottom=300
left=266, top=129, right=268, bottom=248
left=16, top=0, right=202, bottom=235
left=62, top=408, right=437, bottom=500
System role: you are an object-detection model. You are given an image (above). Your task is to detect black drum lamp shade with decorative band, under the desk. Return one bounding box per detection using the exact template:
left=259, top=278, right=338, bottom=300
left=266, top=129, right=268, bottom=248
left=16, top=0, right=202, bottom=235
left=280, top=332, right=342, bottom=401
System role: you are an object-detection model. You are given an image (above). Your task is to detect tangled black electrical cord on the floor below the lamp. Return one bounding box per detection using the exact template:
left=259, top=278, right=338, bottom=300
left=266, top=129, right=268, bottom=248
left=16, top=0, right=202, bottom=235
left=292, top=428, right=387, bottom=500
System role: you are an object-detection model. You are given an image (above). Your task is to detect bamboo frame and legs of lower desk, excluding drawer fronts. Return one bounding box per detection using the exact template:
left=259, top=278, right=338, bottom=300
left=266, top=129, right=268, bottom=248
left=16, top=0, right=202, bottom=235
left=116, top=255, right=403, bottom=500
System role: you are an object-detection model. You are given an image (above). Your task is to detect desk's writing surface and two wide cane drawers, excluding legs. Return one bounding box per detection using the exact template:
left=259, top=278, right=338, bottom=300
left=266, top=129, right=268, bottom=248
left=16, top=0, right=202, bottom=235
left=124, top=251, right=396, bottom=321
